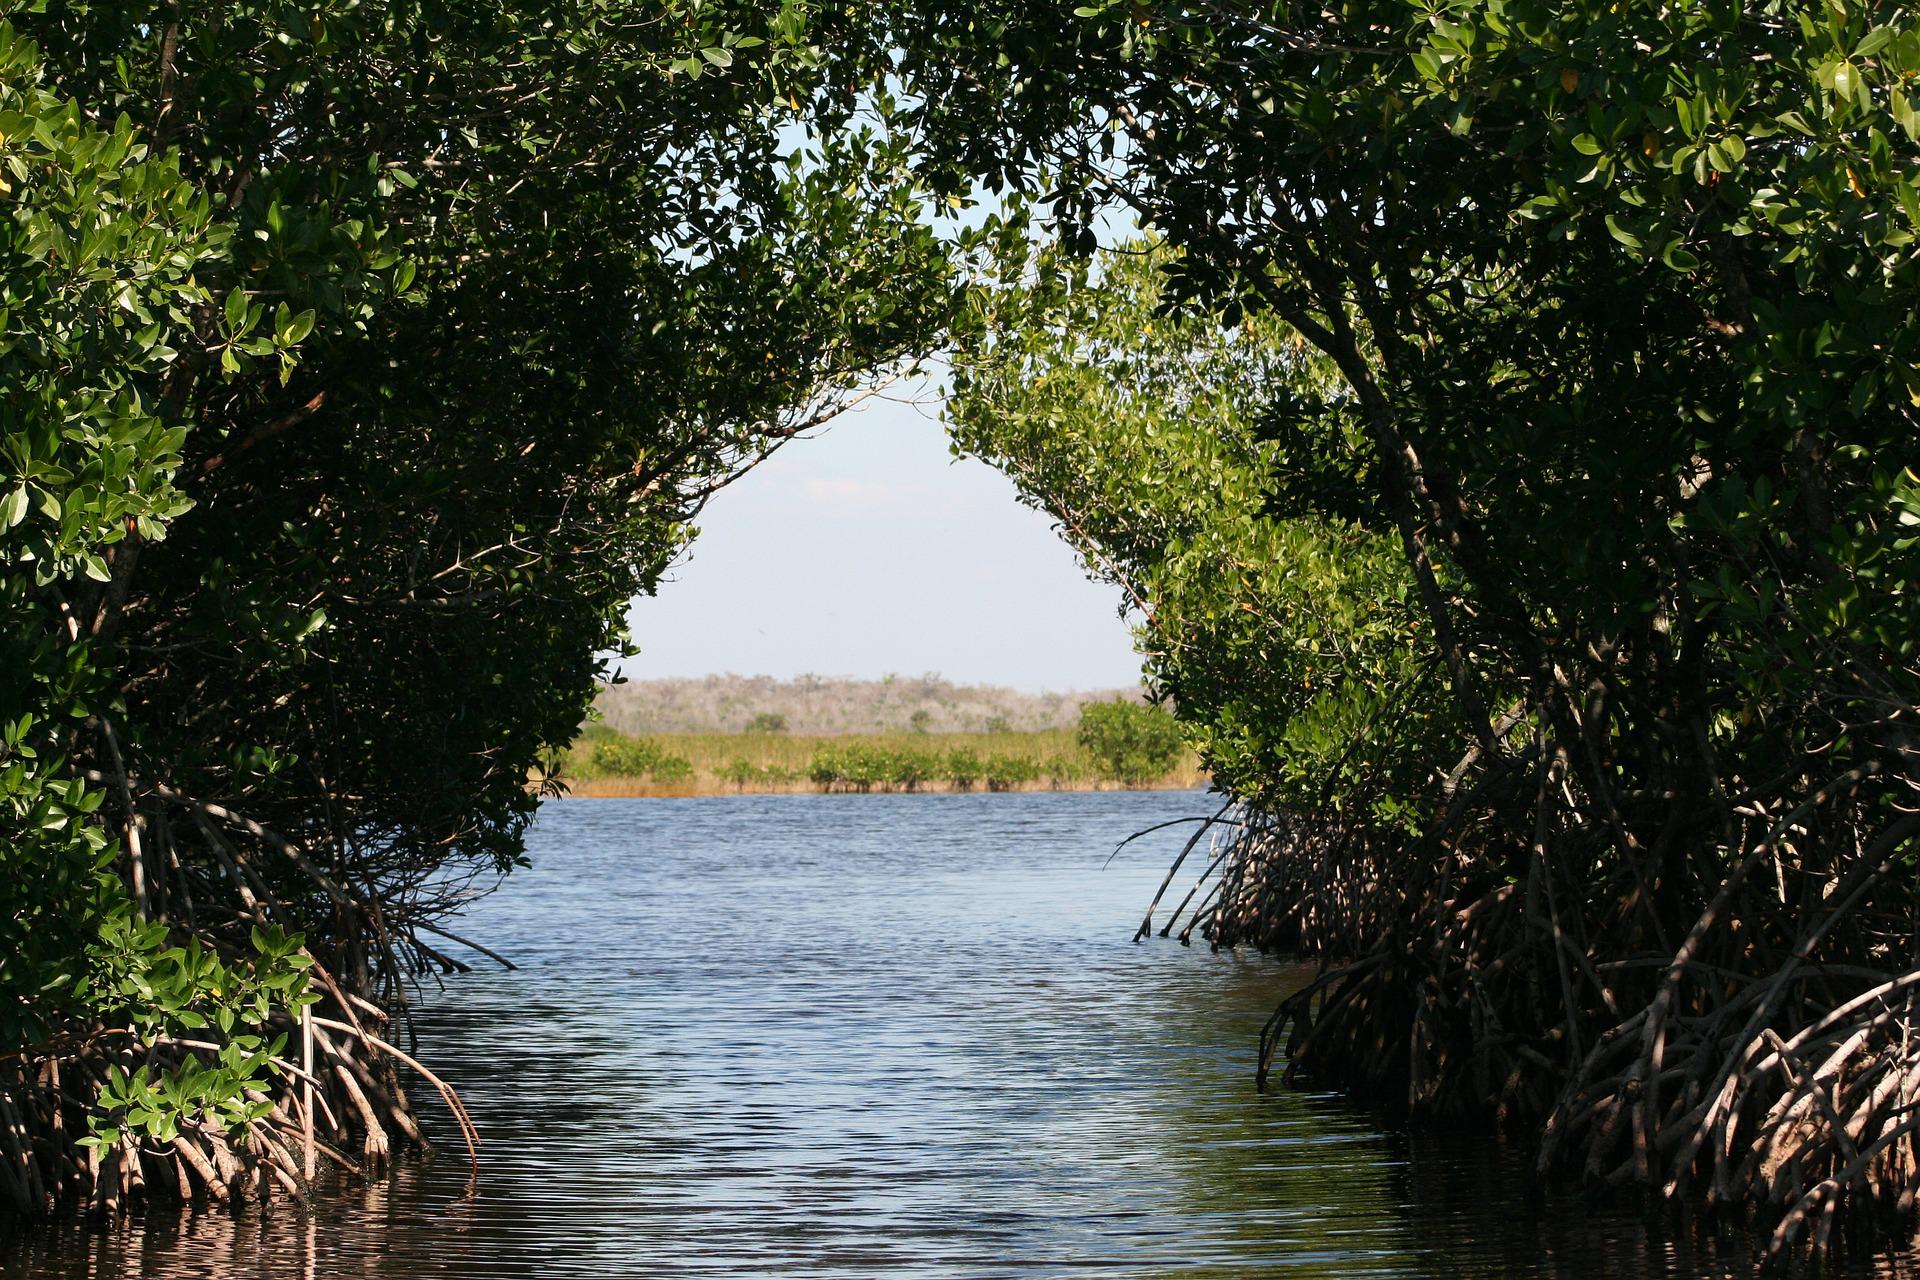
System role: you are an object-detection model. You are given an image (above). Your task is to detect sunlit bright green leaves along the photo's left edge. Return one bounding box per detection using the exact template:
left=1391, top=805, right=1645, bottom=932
left=0, top=14, right=303, bottom=1097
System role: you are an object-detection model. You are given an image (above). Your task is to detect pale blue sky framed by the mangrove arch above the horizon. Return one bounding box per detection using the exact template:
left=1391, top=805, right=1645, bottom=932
left=624, top=401, right=1140, bottom=691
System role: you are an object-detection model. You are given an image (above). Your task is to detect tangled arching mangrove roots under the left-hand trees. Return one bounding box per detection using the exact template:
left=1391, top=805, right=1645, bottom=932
left=0, top=759, right=507, bottom=1215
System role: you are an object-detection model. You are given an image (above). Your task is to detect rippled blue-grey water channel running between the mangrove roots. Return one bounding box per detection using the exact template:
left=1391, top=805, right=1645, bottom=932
left=0, top=793, right=1908, bottom=1280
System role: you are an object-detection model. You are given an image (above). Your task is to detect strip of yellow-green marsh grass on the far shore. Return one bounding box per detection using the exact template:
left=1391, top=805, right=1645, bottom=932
left=559, top=725, right=1208, bottom=796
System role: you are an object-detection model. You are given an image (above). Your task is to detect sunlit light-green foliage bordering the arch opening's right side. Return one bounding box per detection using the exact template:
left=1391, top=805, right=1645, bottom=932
left=950, top=246, right=1448, bottom=818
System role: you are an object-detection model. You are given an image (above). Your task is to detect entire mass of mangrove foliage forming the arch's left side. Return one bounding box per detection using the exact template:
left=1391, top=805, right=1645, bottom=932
left=0, top=0, right=952, bottom=1174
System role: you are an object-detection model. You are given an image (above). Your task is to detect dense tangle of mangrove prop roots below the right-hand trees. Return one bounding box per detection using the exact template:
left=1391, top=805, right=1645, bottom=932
left=1165, top=787, right=1920, bottom=1257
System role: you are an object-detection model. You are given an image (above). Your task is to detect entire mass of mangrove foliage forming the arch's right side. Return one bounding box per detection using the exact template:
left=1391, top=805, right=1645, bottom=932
left=908, top=0, right=1920, bottom=839
